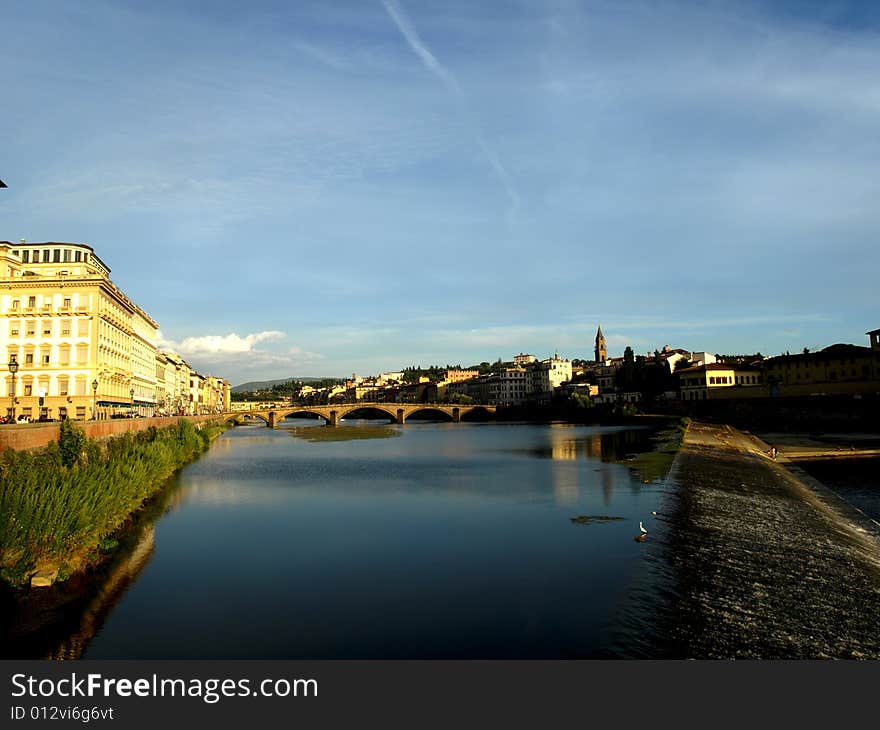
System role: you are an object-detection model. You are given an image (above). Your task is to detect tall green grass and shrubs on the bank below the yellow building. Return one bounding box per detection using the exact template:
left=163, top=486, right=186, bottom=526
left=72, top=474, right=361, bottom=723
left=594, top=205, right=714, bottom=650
left=0, top=421, right=223, bottom=586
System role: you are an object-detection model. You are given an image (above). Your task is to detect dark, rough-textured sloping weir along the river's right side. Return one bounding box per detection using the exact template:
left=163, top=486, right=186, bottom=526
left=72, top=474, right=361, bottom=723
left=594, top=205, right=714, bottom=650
left=656, top=423, right=880, bottom=659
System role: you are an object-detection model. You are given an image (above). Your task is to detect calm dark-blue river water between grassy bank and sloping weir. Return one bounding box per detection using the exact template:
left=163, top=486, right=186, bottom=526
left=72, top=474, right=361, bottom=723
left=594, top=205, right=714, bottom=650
left=8, top=420, right=664, bottom=659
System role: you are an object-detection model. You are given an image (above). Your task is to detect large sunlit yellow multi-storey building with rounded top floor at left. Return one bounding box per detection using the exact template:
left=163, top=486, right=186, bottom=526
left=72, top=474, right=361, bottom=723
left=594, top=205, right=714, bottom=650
left=0, top=241, right=158, bottom=420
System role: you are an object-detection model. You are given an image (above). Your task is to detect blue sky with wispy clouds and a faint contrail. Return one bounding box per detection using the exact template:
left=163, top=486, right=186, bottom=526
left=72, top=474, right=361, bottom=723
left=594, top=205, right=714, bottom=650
left=0, top=0, right=880, bottom=383
